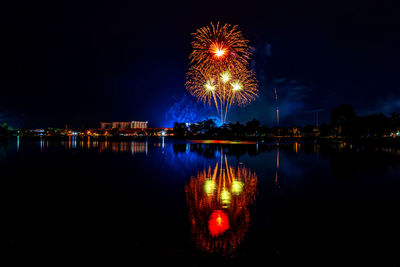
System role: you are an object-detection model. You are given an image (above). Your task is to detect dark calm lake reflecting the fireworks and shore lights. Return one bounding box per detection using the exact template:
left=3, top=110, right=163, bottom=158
left=0, top=137, right=400, bottom=266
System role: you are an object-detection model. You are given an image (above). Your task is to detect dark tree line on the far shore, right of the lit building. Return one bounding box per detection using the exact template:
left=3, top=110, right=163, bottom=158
left=172, top=104, right=400, bottom=139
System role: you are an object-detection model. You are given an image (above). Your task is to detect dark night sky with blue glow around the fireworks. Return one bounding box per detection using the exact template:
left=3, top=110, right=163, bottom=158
left=0, top=0, right=400, bottom=130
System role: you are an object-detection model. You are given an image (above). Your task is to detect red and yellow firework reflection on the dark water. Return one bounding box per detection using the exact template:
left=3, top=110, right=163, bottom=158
left=185, top=156, right=257, bottom=255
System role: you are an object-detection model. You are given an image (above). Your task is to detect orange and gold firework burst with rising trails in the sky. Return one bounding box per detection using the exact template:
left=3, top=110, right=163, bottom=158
left=186, top=23, right=258, bottom=123
